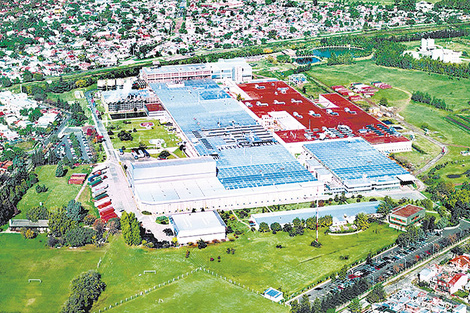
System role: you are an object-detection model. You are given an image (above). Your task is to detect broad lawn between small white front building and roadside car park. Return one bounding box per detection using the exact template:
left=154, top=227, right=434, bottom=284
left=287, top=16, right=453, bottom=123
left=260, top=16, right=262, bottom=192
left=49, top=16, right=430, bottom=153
left=190, top=224, right=398, bottom=294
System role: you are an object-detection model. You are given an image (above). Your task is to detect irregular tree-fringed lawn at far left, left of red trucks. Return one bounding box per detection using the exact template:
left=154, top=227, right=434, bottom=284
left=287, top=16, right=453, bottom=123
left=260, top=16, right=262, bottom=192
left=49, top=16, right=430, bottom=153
left=16, top=165, right=90, bottom=218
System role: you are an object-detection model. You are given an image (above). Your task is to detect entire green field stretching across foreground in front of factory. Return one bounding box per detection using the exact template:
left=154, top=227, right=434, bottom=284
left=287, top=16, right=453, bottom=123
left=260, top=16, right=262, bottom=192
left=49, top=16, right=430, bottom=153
left=0, top=224, right=398, bottom=312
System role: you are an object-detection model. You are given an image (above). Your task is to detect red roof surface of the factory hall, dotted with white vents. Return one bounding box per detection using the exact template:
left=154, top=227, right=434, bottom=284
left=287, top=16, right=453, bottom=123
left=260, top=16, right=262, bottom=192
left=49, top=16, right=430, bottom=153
left=238, top=81, right=408, bottom=144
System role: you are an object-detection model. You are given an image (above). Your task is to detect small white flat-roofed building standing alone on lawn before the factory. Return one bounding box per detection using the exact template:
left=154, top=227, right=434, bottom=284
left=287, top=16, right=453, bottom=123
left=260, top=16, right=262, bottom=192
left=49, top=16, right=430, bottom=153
left=169, top=211, right=226, bottom=244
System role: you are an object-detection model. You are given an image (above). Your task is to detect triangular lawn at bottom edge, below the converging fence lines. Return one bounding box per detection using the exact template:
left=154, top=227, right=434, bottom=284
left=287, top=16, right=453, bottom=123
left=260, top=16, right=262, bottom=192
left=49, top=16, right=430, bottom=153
left=105, top=272, right=289, bottom=313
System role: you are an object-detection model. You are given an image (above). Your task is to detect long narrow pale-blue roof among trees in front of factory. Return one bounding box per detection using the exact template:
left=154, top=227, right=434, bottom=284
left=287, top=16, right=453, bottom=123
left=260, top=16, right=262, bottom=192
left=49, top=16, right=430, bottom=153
left=251, top=201, right=380, bottom=225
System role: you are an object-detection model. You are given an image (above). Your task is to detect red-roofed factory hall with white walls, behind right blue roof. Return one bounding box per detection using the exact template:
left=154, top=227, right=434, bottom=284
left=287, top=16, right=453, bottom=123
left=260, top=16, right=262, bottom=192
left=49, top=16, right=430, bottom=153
left=238, top=81, right=411, bottom=154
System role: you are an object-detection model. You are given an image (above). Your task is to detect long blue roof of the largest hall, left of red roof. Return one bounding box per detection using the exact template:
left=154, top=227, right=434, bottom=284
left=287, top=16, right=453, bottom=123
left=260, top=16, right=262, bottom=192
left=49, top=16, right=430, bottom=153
left=150, top=79, right=316, bottom=189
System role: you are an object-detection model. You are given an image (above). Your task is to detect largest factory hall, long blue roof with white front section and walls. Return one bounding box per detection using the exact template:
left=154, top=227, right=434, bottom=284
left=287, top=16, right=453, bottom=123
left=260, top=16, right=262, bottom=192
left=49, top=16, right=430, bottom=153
left=127, top=80, right=323, bottom=213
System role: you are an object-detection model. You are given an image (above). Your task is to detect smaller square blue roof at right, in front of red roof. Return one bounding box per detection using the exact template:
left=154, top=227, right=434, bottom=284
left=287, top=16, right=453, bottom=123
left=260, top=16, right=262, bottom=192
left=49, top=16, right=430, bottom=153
left=304, top=137, right=409, bottom=182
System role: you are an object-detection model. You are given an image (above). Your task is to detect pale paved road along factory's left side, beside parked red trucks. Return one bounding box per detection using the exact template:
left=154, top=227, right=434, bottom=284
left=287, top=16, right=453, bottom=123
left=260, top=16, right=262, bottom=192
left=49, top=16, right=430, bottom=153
left=85, top=91, right=142, bottom=219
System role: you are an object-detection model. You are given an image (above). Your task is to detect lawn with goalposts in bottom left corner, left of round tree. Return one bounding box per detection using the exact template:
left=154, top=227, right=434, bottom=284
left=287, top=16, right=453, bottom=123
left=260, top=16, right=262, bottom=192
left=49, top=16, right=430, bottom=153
left=0, top=234, right=107, bottom=313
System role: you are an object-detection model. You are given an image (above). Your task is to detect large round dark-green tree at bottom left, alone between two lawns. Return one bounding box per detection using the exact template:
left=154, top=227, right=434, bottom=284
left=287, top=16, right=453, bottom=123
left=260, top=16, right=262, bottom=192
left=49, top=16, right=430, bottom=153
left=61, top=271, right=106, bottom=313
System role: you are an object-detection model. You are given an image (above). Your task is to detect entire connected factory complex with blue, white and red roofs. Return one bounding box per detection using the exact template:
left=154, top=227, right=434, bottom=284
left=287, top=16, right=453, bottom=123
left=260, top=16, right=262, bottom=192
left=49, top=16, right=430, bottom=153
left=120, top=60, right=414, bottom=214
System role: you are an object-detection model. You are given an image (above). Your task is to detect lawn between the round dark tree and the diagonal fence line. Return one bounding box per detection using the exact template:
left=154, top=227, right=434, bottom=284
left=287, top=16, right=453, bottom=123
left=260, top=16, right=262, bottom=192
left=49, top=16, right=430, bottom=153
left=93, top=236, right=196, bottom=311
